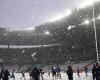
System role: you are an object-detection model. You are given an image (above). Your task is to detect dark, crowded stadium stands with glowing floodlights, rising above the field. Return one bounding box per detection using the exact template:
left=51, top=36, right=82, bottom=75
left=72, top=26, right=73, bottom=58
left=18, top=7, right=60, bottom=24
left=0, top=2, right=100, bottom=64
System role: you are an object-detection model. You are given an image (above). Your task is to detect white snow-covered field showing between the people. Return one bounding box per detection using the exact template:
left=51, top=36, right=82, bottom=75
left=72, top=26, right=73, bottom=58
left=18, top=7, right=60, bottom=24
left=9, top=72, right=92, bottom=80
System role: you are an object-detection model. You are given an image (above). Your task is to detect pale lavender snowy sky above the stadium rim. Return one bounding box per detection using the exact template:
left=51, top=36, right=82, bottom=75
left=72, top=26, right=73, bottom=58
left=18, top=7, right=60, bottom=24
left=0, top=0, right=96, bottom=28
